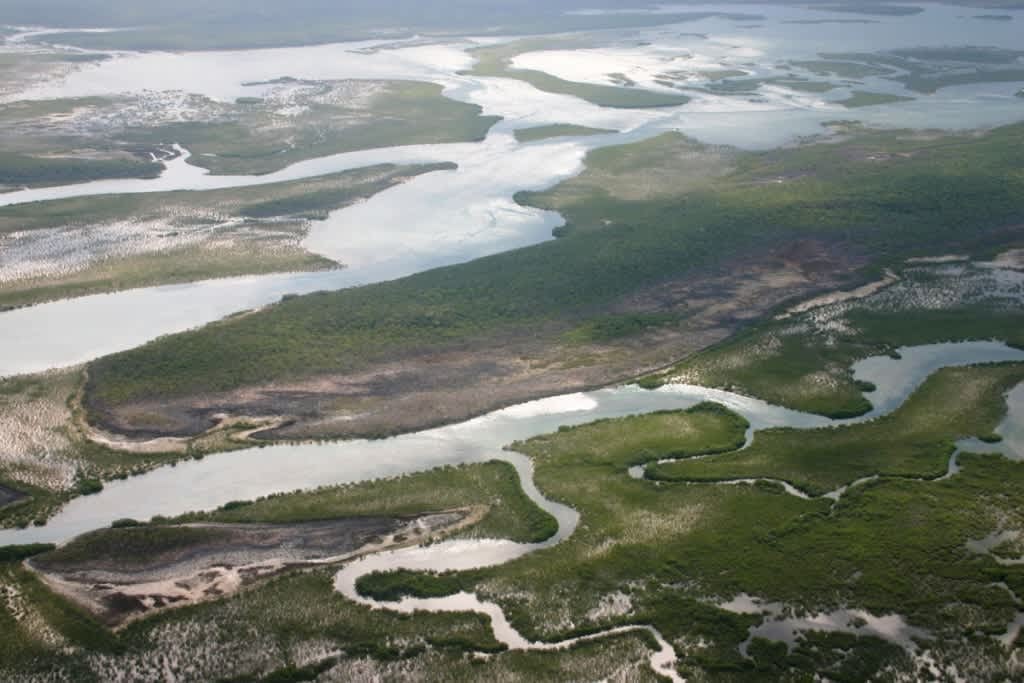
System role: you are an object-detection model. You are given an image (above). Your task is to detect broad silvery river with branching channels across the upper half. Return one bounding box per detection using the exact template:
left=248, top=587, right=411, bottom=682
left=0, top=6, right=1024, bottom=376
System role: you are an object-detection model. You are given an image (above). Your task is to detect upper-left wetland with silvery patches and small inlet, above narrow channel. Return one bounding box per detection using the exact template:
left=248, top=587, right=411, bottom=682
left=0, top=75, right=499, bottom=181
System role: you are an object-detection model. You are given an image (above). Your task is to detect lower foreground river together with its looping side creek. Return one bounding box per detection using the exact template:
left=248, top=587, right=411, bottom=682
left=0, top=342, right=1024, bottom=681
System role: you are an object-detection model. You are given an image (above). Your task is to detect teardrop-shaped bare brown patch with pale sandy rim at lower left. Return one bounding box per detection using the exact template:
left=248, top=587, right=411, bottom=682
left=31, top=508, right=485, bottom=628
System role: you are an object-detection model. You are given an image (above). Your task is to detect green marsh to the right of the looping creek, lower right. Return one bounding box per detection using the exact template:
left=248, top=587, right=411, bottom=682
left=352, top=365, right=1024, bottom=681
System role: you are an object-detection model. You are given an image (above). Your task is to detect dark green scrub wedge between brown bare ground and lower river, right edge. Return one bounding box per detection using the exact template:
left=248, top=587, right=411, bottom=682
left=641, top=262, right=1024, bottom=418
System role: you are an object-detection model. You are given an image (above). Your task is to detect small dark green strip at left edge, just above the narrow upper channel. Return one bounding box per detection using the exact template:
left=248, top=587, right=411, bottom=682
left=0, top=152, right=164, bottom=187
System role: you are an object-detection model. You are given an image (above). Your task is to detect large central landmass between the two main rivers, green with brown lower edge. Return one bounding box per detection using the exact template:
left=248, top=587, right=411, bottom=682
left=86, top=126, right=1024, bottom=434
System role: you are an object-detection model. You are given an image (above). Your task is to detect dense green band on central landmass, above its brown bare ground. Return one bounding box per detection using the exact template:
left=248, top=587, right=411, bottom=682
left=88, top=125, right=1024, bottom=408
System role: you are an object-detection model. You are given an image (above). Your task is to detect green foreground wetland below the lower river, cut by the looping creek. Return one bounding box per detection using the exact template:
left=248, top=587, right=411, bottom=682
left=8, top=356, right=1024, bottom=681
